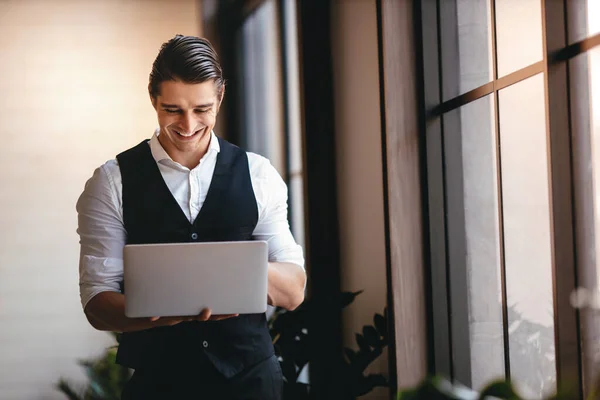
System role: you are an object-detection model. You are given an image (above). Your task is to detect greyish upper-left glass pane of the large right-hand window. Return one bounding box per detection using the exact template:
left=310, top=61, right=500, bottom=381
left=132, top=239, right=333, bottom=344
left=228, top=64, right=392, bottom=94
left=441, top=0, right=492, bottom=100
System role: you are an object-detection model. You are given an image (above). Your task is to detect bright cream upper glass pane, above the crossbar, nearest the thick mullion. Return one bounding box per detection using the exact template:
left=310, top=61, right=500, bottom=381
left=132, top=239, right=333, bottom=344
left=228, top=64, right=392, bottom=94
left=496, top=0, right=543, bottom=77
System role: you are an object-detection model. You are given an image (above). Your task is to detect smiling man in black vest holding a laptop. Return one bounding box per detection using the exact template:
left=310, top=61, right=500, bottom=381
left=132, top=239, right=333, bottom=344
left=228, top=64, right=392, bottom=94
left=77, top=35, right=306, bottom=400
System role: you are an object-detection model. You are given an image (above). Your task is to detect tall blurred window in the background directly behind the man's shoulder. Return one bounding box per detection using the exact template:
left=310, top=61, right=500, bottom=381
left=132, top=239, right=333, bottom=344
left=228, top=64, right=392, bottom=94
left=238, top=0, right=304, bottom=246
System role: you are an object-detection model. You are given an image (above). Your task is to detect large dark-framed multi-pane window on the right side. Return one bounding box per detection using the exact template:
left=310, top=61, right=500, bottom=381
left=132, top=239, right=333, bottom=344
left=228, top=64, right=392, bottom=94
left=420, top=0, right=600, bottom=398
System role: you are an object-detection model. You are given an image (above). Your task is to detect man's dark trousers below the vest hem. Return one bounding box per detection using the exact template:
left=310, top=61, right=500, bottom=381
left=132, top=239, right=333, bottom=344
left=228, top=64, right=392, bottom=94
left=121, top=356, right=283, bottom=400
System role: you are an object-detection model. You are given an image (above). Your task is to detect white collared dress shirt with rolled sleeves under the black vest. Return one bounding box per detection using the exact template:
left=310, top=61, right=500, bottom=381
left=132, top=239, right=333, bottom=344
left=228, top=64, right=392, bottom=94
left=77, top=132, right=304, bottom=308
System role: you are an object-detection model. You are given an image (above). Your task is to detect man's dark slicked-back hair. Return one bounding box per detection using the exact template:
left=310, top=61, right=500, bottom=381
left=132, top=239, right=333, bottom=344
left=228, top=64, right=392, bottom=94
left=148, top=35, right=225, bottom=99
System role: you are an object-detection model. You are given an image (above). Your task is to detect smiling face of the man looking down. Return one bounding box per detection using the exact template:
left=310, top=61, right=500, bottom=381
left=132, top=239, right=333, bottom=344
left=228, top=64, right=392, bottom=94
left=152, top=80, right=220, bottom=161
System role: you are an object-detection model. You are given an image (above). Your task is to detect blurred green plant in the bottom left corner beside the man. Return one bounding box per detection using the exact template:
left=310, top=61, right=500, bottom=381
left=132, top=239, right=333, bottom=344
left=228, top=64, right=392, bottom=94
left=56, top=333, right=131, bottom=400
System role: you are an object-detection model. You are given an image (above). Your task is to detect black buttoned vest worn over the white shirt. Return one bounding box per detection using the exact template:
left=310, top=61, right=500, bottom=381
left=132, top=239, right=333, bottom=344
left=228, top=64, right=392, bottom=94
left=117, top=139, right=273, bottom=377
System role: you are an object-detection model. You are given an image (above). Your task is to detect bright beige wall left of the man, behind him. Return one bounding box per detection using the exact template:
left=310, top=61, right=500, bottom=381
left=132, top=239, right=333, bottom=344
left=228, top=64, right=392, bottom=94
left=0, top=0, right=200, bottom=400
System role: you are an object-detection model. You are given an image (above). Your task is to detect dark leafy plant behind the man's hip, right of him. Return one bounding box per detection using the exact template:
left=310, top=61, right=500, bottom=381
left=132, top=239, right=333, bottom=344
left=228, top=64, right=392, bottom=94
left=269, top=292, right=389, bottom=400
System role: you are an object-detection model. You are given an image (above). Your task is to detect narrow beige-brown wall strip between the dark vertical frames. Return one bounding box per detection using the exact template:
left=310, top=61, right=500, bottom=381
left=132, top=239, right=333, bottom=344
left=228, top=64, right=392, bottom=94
left=332, top=0, right=388, bottom=399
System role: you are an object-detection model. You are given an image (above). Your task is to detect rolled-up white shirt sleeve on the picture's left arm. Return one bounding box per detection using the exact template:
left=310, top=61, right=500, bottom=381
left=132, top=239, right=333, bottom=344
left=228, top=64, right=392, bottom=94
left=77, top=162, right=127, bottom=309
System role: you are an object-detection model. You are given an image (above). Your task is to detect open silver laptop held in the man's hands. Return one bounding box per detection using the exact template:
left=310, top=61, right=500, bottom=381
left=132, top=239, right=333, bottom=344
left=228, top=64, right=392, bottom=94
left=123, top=241, right=268, bottom=318
